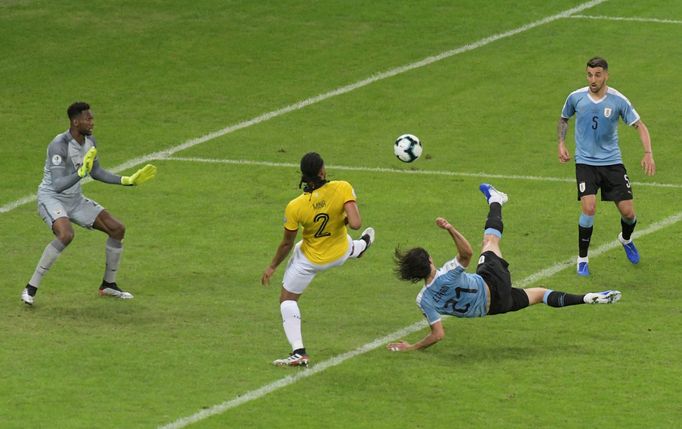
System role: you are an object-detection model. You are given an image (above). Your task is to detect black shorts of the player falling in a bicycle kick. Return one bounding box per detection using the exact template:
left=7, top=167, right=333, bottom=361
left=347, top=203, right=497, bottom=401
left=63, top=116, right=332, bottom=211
left=476, top=251, right=529, bottom=315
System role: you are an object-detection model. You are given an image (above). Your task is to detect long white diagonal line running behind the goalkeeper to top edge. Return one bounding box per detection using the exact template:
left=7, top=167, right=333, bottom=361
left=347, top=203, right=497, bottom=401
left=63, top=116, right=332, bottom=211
left=0, top=0, right=606, bottom=213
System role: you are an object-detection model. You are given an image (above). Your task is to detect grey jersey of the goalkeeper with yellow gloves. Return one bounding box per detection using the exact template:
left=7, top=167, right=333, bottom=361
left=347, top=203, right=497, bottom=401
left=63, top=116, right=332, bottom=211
left=38, top=130, right=121, bottom=197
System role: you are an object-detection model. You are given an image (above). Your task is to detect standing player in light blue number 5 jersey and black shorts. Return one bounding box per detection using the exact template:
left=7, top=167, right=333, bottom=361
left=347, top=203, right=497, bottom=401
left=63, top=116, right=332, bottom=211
left=557, top=57, right=656, bottom=276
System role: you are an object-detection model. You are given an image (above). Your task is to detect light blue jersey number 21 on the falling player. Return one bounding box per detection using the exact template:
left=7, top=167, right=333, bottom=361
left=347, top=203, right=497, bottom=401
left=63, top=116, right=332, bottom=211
left=417, top=258, right=487, bottom=325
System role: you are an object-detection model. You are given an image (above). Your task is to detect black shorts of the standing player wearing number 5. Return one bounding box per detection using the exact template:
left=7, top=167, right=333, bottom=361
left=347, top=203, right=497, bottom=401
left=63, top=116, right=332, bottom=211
left=575, top=164, right=632, bottom=202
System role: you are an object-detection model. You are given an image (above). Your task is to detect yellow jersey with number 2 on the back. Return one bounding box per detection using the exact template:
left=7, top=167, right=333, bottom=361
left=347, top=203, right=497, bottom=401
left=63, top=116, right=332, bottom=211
left=284, top=180, right=355, bottom=264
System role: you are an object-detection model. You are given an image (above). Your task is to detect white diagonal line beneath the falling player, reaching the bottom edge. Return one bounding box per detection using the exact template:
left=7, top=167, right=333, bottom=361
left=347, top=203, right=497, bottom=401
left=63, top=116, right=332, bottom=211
left=160, top=207, right=682, bottom=429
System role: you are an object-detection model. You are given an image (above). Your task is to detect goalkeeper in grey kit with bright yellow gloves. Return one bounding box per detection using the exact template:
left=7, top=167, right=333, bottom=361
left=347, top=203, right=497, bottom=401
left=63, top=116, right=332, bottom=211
left=21, top=102, right=156, bottom=305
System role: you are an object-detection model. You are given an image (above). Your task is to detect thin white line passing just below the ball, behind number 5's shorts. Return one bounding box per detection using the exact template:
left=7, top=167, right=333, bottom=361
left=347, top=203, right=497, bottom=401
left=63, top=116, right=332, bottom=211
left=164, top=156, right=682, bottom=189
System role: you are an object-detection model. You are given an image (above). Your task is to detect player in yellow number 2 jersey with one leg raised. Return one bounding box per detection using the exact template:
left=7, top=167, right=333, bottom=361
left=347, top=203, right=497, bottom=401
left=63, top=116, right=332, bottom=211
left=261, top=152, right=374, bottom=366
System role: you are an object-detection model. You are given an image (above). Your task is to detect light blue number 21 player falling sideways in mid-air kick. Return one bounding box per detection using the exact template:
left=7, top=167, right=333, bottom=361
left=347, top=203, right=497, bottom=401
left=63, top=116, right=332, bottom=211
left=387, top=183, right=621, bottom=352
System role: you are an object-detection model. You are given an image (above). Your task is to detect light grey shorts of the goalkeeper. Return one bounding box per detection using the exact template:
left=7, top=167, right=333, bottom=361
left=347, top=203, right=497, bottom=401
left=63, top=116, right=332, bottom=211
left=38, top=192, right=104, bottom=229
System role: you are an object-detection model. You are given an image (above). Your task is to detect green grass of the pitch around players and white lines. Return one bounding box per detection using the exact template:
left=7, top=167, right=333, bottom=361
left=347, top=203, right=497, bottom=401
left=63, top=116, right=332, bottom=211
left=0, top=1, right=682, bottom=428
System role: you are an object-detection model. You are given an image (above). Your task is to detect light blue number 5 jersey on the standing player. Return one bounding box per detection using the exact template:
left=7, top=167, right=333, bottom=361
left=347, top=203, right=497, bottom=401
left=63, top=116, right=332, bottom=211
left=561, top=86, right=639, bottom=165
